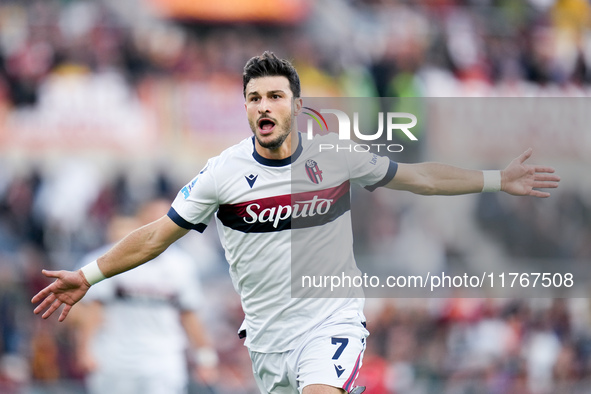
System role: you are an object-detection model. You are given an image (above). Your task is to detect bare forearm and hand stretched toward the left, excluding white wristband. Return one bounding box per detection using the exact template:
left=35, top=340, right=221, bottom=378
left=31, top=215, right=189, bottom=321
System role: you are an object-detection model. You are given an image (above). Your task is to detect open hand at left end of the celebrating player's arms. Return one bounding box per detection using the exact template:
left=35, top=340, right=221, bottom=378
left=31, top=270, right=90, bottom=321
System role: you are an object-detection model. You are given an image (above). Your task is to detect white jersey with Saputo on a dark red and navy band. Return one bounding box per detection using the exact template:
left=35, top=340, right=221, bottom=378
left=168, top=134, right=397, bottom=353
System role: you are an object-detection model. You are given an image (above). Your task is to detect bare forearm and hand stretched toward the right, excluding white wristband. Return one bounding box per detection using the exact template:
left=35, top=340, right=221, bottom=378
left=386, top=148, right=560, bottom=197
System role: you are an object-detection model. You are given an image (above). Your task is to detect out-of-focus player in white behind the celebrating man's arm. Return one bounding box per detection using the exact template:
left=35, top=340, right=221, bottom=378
left=70, top=199, right=217, bottom=394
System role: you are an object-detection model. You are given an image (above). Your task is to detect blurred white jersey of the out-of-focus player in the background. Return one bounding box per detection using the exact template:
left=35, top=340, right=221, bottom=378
left=83, top=245, right=203, bottom=382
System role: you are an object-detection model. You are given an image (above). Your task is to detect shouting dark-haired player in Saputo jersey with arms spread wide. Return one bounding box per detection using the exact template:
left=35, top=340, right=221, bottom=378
left=32, top=52, right=559, bottom=394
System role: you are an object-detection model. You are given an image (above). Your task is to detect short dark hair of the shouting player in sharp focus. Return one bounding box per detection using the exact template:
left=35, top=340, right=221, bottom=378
left=242, top=51, right=300, bottom=97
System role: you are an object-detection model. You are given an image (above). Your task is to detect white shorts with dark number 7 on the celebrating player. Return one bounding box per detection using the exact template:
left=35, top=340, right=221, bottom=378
left=249, top=318, right=369, bottom=394
